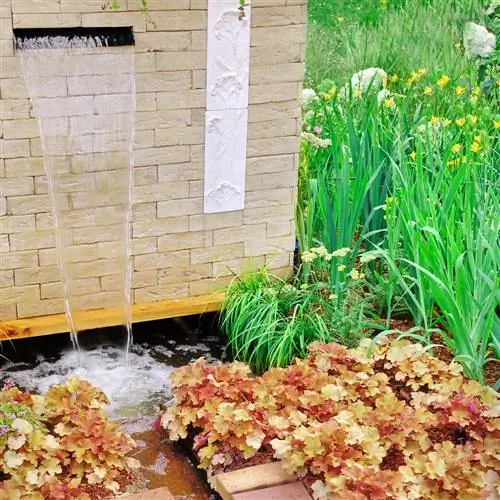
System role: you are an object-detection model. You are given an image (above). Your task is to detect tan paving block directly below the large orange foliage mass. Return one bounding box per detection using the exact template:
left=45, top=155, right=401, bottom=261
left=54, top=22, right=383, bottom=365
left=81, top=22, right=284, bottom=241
left=210, top=462, right=300, bottom=500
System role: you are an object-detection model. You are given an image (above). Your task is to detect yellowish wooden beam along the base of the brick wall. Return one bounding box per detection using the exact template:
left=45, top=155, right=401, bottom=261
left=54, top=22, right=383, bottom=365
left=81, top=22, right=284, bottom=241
left=0, top=293, right=224, bottom=341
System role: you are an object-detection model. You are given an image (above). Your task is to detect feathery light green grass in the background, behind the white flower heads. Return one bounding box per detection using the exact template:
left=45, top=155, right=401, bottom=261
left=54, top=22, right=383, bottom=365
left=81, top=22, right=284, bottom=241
left=306, top=0, right=491, bottom=88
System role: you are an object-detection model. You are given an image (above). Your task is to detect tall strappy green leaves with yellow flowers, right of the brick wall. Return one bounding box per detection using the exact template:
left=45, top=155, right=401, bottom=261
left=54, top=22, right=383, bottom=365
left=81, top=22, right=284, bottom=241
left=297, top=68, right=500, bottom=382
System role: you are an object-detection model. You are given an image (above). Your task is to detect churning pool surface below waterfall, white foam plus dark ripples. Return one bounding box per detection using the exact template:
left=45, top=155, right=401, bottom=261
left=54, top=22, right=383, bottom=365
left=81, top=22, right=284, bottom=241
left=2, top=342, right=216, bottom=422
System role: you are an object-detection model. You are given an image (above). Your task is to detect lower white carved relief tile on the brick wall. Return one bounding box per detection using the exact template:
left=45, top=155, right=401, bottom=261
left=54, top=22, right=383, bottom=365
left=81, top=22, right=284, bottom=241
left=205, top=109, right=248, bottom=213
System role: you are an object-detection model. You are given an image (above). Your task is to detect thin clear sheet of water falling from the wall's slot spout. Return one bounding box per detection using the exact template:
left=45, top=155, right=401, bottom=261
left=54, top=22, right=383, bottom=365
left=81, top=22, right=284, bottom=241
left=17, top=36, right=135, bottom=365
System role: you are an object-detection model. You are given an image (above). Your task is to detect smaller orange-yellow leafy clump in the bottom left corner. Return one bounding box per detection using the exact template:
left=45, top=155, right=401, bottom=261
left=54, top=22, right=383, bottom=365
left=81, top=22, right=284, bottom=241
left=0, top=379, right=137, bottom=500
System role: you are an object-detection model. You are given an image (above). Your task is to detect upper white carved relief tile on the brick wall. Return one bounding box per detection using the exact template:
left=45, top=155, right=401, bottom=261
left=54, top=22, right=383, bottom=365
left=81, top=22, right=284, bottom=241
left=207, top=0, right=251, bottom=110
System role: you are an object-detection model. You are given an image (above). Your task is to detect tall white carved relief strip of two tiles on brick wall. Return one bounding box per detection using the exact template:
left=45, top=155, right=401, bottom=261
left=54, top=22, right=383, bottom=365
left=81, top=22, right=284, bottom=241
left=204, top=0, right=251, bottom=213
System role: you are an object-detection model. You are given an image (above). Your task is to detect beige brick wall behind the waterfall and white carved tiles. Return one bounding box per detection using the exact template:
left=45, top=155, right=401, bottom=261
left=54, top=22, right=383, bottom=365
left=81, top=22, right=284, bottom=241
left=0, top=0, right=307, bottom=321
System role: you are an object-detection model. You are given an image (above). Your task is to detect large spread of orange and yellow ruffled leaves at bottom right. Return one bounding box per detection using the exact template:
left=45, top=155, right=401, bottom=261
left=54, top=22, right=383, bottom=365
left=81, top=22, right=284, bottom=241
left=162, top=339, right=500, bottom=500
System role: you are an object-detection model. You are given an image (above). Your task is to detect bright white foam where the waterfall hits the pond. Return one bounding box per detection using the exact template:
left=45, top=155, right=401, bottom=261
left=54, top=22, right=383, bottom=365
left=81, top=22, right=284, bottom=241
left=4, top=345, right=174, bottom=421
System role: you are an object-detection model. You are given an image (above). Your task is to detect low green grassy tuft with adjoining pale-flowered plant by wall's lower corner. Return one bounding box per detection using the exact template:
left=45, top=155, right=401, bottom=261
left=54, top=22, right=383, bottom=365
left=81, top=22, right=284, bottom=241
left=221, top=268, right=373, bottom=373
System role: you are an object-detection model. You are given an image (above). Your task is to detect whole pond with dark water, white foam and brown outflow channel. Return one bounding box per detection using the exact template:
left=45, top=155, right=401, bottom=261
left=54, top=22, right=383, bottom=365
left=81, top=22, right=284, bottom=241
left=0, top=315, right=224, bottom=500
